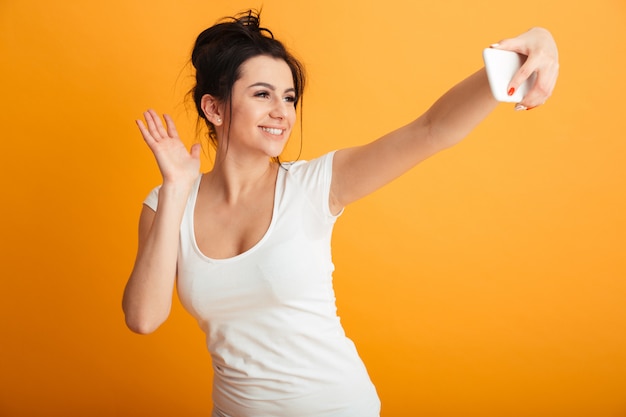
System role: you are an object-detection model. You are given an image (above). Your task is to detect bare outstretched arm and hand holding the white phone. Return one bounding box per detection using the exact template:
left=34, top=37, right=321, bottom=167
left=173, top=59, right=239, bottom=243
left=330, top=28, right=559, bottom=213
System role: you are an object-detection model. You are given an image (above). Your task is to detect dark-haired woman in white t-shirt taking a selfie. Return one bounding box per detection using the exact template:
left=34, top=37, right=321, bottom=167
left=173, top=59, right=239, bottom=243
left=123, top=12, right=558, bottom=417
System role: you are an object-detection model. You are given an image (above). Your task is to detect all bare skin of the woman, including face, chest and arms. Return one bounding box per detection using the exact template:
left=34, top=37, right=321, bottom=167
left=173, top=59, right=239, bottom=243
left=123, top=28, right=559, bottom=334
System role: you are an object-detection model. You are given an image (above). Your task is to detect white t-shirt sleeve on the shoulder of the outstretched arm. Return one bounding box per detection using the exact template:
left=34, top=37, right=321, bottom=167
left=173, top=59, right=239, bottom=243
left=288, top=151, right=343, bottom=220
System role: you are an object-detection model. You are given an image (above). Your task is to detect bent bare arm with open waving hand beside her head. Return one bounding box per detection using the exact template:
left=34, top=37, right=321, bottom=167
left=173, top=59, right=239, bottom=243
left=122, top=111, right=200, bottom=334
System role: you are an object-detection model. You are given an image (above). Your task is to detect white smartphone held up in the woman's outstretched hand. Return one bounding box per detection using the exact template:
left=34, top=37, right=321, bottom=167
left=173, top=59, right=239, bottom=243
left=483, top=48, right=536, bottom=103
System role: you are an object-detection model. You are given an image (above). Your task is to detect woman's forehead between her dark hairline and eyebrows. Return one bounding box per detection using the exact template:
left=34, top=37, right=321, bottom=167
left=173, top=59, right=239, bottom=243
left=239, top=55, right=294, bottom=89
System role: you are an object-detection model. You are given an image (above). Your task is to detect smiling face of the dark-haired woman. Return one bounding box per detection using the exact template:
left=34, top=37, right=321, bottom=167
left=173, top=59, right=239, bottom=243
left=224, top=55, right=296, bottom=157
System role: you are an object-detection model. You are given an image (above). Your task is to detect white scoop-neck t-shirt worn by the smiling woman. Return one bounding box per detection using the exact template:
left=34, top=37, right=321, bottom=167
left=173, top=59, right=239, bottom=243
left=145, top=153, right=380, bottom=417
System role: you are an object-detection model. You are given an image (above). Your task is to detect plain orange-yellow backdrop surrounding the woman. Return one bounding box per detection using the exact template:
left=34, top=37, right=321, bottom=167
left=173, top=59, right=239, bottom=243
left=0, top=0, right=626, bottom=417
